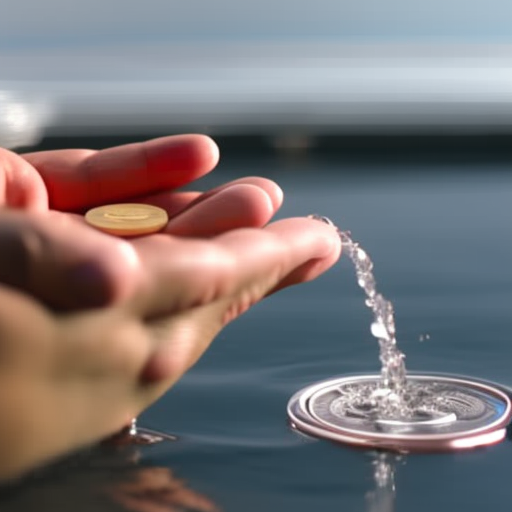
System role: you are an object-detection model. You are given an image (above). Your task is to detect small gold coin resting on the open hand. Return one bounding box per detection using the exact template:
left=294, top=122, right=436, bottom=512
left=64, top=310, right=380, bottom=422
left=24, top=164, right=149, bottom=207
left=85, top=203, right=169, bottom=236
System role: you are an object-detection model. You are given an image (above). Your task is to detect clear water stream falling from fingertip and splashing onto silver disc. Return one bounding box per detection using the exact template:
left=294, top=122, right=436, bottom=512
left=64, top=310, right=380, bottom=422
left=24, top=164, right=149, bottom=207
left=311, top=215, right=472, bottom=426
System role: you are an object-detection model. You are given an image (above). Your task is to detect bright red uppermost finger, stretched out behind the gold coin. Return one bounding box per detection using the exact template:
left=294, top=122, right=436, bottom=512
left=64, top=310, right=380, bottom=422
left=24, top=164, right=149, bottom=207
left=23, top=135, right=219, bottom=211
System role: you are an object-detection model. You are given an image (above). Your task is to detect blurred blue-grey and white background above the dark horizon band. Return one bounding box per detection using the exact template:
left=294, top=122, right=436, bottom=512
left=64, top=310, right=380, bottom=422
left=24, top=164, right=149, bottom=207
left=0, top=0, right=512, bottom=146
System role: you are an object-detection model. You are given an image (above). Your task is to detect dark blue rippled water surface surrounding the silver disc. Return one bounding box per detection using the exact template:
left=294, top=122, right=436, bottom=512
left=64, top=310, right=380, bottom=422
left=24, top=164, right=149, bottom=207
left=4, top=146, right=512, bottom=512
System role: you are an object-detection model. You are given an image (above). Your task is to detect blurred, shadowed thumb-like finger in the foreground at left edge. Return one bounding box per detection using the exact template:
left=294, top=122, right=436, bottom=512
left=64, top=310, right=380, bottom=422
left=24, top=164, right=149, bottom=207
left=0, top=211, right=138, bottom=310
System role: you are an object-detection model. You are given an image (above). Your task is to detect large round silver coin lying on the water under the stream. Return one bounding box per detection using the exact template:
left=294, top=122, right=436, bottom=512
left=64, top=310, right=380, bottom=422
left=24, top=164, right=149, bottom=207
left=288, top=375, right=512, bottom=451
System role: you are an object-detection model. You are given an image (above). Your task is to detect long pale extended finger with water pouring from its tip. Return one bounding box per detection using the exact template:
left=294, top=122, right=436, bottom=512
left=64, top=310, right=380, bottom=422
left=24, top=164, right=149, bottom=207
left=131, top=218, right=341, bottom=317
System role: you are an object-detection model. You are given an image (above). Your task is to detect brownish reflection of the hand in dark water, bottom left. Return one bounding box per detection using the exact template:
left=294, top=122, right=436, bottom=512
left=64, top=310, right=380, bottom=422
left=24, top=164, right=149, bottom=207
left=0, top=439, right=219, bottom=512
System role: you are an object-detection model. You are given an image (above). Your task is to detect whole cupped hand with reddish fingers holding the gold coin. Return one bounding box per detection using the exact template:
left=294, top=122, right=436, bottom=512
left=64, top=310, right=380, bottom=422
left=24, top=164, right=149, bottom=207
left=0, top=135, right=341, bottom=478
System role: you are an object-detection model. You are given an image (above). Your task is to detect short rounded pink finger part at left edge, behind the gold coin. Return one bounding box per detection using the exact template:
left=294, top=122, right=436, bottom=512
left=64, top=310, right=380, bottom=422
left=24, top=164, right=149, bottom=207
left=0, top=148, right=48, bottom=210
